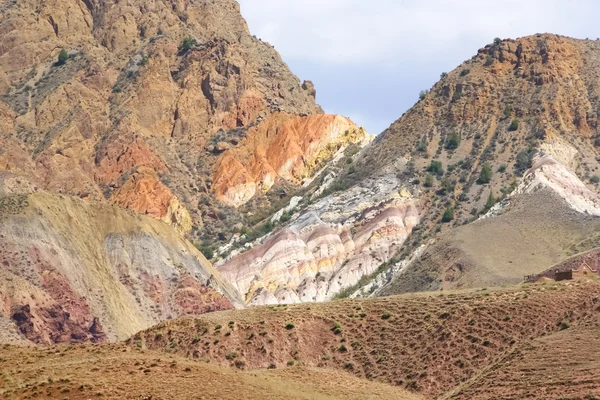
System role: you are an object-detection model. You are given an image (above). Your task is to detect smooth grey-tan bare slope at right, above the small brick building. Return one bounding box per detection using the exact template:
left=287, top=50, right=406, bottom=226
left=378, top=190, right=600, bottom=296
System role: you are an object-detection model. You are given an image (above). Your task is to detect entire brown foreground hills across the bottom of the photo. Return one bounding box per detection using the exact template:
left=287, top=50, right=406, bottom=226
left=0, top=282, right=600, bottom=399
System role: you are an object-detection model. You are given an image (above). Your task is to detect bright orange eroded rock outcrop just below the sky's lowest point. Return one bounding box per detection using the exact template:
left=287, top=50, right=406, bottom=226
left=213, top=113, right=368, bottom=207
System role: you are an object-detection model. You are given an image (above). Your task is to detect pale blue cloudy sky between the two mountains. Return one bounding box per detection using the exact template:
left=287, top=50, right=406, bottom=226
left=238, top=0, right=600, bottom=134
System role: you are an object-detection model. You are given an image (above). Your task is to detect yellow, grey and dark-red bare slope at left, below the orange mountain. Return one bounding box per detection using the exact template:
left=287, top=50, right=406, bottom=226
left=0, top=173, right=240, bottom=344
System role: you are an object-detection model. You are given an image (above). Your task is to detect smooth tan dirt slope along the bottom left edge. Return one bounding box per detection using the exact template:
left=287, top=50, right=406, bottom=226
left=0, top=346, right=421, bottom=400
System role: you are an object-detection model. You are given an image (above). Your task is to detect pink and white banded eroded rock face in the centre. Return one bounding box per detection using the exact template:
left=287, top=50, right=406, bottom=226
left=217, top=176, right=420, bottom=305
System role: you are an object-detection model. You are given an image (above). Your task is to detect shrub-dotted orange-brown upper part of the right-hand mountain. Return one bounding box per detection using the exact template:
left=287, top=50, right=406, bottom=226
left=346, top=34, right=600, bottom=236
